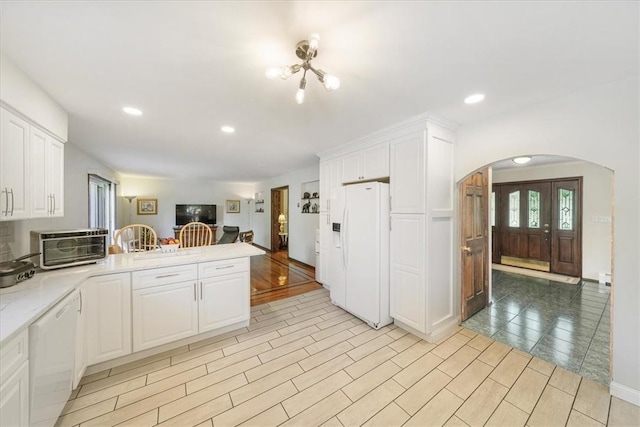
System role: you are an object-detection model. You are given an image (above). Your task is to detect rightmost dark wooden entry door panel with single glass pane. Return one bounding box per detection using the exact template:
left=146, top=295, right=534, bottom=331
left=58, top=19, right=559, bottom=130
left=551, top=178, right=582, bottom=277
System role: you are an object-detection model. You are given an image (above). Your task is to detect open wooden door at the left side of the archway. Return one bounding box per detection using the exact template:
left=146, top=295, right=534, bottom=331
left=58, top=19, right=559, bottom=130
left=461, top=169, right=489, bottom=320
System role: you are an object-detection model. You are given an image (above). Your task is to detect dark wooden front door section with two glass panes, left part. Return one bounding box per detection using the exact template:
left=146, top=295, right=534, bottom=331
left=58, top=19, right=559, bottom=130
left=495, top=182, right=552, bottom=271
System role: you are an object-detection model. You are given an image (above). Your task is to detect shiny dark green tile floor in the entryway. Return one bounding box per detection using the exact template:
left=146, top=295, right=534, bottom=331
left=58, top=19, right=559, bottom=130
left=462, top=269, right=611, bottom=385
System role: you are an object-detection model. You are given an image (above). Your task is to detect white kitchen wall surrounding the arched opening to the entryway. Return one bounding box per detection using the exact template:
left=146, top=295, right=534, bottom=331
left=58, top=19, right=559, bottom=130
left=456, top=76, right=640, bottom=405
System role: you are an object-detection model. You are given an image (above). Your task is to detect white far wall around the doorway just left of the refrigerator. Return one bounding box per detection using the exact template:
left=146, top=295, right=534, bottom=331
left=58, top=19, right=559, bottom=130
left=253, top=165, right=320, bottom=266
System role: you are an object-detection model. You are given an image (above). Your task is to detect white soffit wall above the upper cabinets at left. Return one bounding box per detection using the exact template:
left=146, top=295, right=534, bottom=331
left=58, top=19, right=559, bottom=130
left=0, top=52, right=69, bottom=141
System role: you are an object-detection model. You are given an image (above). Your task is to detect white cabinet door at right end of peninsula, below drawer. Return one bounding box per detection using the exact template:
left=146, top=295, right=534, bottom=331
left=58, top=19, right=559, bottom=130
left=198, top=272, right=251, bottom=333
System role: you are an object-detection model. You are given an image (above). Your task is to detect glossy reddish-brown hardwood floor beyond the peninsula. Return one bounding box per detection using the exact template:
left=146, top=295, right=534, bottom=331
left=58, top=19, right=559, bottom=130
left=251, top=248, right=322, bottom=306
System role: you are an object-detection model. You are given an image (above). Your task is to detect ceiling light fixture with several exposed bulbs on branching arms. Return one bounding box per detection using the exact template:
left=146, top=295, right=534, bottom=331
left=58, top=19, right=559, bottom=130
left=265, top=33, right=340, bottom=104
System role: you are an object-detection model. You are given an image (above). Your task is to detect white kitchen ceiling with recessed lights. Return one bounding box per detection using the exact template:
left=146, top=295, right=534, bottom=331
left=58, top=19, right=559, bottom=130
left=0, top=1, right=639, bottom=182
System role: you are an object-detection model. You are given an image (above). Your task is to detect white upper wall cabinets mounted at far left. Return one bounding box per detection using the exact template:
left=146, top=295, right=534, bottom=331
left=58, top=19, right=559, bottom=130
left=0, top=108, right=64, bottom=221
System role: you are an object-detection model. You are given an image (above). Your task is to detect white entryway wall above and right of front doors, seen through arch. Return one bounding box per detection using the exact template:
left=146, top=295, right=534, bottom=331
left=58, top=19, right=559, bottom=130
left=493, top=161, right=613, bottom=281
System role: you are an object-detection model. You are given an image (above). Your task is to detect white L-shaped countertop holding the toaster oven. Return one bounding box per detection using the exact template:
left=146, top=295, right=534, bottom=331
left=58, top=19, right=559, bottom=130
left=0, top=243, right=265, bottom=344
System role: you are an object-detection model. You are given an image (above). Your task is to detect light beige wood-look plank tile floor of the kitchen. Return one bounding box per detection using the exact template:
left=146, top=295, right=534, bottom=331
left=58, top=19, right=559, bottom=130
left=57, top=289, right=640, bottom=427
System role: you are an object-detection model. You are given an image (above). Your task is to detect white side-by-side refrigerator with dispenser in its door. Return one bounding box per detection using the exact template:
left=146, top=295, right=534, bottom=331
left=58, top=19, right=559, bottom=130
left=327, top=182, right=393, bottom=329
